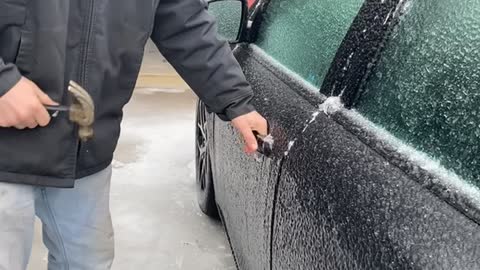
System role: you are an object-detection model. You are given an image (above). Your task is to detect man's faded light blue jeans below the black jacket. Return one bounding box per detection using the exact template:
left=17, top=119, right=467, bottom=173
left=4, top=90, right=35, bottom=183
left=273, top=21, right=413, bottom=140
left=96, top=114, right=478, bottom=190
left=0, top=167, right=114, bottom=270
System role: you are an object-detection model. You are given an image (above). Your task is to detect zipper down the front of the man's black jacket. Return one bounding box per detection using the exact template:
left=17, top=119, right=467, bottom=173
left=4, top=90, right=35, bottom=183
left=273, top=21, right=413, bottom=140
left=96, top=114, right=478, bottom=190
left=73, top=0, right=95, bottom=178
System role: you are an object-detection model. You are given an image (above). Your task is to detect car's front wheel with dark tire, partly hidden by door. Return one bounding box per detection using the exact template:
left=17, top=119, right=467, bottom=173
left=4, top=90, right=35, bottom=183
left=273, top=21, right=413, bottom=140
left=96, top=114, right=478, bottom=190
left=195, top=102, right=218, bottom=218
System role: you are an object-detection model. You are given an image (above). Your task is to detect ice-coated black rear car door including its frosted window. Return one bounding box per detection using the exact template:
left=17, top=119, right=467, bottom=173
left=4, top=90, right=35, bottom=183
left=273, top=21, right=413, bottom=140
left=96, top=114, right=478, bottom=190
left=272, top=0, right=480, bottom=269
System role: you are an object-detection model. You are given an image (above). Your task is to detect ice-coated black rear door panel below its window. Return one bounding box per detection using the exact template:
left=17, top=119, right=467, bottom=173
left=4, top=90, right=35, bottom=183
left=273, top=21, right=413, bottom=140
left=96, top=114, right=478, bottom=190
left=273, top=108, right=480, bottom=269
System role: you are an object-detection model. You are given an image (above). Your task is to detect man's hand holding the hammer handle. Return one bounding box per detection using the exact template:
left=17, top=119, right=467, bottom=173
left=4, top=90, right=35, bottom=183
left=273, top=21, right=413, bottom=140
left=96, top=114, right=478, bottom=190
left=0, top=77, right=57, bottom=129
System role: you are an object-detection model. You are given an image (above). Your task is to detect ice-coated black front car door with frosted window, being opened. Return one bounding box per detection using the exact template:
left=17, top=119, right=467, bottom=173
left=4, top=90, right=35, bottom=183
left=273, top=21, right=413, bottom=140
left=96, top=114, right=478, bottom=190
left=214, top=0, right=361, bottom=269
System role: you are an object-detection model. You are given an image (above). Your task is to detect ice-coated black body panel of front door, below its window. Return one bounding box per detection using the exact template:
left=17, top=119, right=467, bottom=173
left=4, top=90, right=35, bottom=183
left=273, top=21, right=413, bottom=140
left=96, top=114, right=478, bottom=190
left=214, top=43, right=330, bottom=269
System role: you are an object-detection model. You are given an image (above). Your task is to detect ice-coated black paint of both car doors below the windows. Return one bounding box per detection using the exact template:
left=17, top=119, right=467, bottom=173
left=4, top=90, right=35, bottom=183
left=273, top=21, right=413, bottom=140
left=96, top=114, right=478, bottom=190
left=202, top=0, right=480, bottom=269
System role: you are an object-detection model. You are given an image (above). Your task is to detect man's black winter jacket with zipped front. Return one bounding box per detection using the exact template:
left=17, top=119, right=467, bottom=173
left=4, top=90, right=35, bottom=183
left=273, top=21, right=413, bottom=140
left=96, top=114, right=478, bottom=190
left=0, top=0, right=254, bottom=187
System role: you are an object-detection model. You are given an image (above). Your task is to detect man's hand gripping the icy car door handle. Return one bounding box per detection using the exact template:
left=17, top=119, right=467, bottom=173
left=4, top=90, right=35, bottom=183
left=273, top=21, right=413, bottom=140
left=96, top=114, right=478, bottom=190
left=232, top=112, right=268, bottom=154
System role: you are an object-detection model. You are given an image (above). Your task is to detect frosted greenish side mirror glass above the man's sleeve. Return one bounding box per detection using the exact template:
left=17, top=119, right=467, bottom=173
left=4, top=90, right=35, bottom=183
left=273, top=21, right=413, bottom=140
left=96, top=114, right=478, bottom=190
left=208, top=1, right=242, bottom=41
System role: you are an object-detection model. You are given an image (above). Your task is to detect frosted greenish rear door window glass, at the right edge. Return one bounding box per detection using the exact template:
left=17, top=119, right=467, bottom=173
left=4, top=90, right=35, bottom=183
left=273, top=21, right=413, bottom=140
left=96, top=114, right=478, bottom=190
left=359, top=0, right=480, bottom=185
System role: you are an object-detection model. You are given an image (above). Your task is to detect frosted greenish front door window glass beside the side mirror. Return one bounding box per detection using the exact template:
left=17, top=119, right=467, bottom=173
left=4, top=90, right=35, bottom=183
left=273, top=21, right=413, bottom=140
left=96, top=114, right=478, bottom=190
left=257, top=0, right=364, bottom=86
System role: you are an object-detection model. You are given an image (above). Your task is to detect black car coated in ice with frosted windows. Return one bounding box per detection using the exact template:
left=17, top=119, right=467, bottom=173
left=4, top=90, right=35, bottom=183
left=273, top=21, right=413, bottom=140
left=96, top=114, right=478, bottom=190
left=196, top=0, right=480, bottom=270
